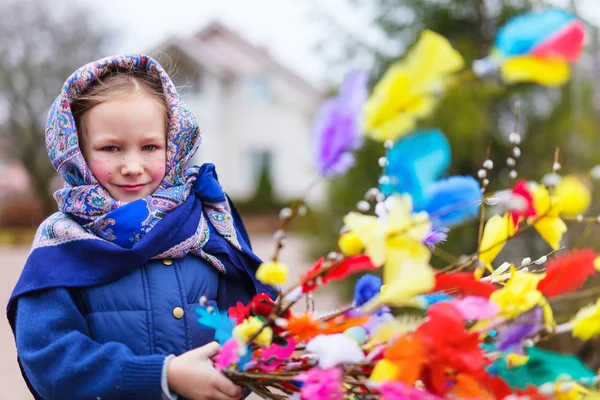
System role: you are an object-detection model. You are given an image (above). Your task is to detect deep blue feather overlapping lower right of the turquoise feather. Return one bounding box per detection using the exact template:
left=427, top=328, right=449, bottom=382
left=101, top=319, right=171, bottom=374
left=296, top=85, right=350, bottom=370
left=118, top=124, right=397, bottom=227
left=415, top=176, right=481, bottom=227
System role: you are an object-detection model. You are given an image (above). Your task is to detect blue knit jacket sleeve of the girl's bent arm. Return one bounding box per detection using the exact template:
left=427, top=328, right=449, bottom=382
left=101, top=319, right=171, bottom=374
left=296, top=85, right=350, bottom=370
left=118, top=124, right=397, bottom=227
left=15, top=289, right=165, bottom=400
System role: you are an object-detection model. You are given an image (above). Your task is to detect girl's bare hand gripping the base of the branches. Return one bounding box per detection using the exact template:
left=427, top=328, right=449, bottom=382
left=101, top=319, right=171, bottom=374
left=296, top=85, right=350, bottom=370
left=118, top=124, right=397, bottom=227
left=167, top=342, right=243, bottom=400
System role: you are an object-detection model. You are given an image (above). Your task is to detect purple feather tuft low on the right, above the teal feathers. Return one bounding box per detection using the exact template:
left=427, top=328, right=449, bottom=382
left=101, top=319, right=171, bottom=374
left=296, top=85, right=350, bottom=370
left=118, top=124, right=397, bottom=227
left=495, top=307, right=544, bottom=354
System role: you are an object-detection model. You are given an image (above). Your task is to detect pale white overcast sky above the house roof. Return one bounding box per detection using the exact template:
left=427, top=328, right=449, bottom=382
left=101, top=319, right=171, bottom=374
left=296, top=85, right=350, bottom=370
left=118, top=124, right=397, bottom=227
left=79, top=0, right=600, bottom=85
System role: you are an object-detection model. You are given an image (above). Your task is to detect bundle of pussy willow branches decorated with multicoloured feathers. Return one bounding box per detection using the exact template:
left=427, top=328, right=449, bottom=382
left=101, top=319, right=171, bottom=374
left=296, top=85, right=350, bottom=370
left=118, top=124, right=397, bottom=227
left=197, top=10, right=600, bottom=400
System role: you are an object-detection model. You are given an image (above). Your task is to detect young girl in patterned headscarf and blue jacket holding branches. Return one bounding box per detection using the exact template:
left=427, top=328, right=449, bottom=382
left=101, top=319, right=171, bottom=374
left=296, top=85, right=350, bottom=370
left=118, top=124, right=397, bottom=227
left=7, top=55, right=272, bottom=400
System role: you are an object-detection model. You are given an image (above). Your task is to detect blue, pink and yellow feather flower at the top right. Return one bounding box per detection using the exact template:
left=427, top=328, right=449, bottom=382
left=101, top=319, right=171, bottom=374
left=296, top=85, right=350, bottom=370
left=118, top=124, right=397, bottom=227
left=473, top=9, right=585, bottom=86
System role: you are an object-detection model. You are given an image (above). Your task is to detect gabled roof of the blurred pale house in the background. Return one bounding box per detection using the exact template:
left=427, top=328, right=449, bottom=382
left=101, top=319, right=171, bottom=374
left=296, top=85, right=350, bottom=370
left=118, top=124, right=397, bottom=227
left=161, top=22, right=322, bottom=96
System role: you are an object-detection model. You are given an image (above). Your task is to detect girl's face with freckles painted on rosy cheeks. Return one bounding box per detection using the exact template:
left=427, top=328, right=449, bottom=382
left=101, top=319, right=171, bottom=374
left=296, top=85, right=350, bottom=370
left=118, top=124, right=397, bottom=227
left=81, top=91, right=167, bottom=202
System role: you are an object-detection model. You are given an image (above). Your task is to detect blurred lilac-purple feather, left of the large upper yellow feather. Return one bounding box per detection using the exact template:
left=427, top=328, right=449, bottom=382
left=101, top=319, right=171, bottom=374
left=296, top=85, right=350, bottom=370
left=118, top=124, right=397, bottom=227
left=313, top=71, right=368, bottom=176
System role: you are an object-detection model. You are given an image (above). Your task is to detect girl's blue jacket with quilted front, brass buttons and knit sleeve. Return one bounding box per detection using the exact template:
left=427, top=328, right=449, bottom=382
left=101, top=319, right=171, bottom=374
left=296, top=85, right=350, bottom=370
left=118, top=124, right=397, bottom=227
left=16, top=255, right=255, bottom=400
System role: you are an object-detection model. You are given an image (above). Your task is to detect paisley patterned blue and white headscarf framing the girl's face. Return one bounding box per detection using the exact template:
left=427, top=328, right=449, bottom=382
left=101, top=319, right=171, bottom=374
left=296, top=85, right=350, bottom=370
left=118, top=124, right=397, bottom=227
left=33, top=54, right=242, bottom=272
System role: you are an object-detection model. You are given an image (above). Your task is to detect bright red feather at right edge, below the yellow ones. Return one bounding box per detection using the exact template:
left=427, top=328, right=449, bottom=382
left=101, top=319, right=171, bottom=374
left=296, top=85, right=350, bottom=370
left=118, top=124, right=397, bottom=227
left=538, top=249, right=597, bottom=297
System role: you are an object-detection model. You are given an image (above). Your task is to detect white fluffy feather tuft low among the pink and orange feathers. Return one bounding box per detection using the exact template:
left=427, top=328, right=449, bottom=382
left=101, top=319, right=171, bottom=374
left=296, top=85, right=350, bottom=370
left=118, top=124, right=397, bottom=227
left=306, top=334, right=365, bottom=369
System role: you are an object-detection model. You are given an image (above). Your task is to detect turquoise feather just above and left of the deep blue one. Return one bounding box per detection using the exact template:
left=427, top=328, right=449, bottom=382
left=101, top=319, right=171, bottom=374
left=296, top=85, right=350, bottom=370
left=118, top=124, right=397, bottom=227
left=380, top=129, right=451, bottom=207
